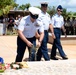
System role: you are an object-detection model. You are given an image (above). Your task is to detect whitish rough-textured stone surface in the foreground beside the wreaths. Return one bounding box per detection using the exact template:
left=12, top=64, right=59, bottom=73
left=0, top=59, right=76, bottom=75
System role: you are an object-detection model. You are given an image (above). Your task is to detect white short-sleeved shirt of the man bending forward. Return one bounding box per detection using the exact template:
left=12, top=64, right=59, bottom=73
left=18, top=16, right=44, bottom=38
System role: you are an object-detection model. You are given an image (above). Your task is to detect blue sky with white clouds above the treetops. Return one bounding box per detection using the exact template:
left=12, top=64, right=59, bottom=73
left=16, top=0, right=76, bottom=12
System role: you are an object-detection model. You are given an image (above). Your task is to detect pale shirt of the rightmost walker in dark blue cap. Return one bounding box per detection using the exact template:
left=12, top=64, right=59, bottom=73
left=52, top=14, right=64, bottom=28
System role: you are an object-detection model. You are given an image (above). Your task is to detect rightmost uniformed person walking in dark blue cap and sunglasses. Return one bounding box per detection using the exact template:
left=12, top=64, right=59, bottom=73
left=50, top=5, right=68, bottom=60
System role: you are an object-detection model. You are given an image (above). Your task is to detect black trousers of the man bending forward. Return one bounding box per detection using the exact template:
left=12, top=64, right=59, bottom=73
left=15, top=36, right=36, bottom=62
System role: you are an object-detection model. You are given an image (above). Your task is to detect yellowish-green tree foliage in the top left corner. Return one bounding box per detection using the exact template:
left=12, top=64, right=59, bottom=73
left=0, top=0, right=17, bottom=16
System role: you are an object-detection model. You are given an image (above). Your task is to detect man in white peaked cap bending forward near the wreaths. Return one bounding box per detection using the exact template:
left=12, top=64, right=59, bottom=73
left=15, top=7, right=44, bottom=62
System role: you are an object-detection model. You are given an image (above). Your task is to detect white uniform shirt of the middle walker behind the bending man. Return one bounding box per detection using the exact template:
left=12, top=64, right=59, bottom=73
left=39, top=12, right=51, bottom=30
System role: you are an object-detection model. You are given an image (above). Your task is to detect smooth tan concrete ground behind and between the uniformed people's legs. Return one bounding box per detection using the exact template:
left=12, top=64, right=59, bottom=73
left=0, top=36, right=76, bottom=63
